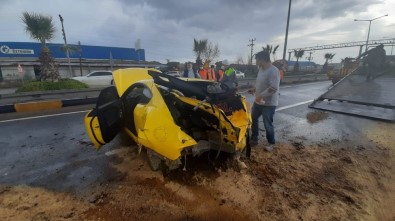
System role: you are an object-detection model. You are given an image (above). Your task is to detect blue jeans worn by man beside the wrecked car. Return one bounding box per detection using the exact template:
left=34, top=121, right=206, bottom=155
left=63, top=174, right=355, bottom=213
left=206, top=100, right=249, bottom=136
left=251, top=103, right=276, bottom=144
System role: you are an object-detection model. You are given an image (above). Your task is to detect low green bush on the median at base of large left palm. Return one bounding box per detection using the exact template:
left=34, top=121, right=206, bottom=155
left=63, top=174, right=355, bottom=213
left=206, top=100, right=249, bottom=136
left=16, top=79, right=88, bottom=93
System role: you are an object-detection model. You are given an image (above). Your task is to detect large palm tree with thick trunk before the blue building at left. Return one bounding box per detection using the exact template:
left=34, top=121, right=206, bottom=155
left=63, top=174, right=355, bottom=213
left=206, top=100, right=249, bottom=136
left=22, top=12, right=59, bottom=81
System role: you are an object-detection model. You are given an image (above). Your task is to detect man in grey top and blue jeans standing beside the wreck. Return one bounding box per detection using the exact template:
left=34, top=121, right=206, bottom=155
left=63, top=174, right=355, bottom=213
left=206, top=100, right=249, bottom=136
left=248, top=51, right=280, bottom=151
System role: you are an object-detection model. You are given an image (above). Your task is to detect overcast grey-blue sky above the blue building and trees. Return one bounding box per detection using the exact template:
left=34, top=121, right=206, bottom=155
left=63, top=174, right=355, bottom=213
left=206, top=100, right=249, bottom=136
left=0, top=0, right=395, bottom=63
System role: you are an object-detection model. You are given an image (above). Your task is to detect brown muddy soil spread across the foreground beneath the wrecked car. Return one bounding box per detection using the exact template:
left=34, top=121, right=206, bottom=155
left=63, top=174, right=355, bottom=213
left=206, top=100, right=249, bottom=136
left=0, top=139, right=395, bottom=221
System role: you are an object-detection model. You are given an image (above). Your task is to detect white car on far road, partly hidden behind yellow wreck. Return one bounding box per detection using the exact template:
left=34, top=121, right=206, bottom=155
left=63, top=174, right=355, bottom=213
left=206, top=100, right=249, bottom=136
left=72, top=71, right=114, bottom=87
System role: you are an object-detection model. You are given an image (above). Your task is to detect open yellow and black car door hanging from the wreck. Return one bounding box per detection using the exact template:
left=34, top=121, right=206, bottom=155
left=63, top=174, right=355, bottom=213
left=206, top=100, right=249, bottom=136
left=84, top=86, right=124, bottom=149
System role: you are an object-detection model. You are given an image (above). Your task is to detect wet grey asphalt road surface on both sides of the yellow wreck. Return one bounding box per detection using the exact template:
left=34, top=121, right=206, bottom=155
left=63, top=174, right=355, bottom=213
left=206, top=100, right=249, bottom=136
left=0, top=81, right=392, bottom=193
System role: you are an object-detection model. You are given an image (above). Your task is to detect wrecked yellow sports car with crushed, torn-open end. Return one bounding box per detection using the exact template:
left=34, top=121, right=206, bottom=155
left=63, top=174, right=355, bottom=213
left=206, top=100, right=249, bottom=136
left=84, top=68, right=250, bottom=170
